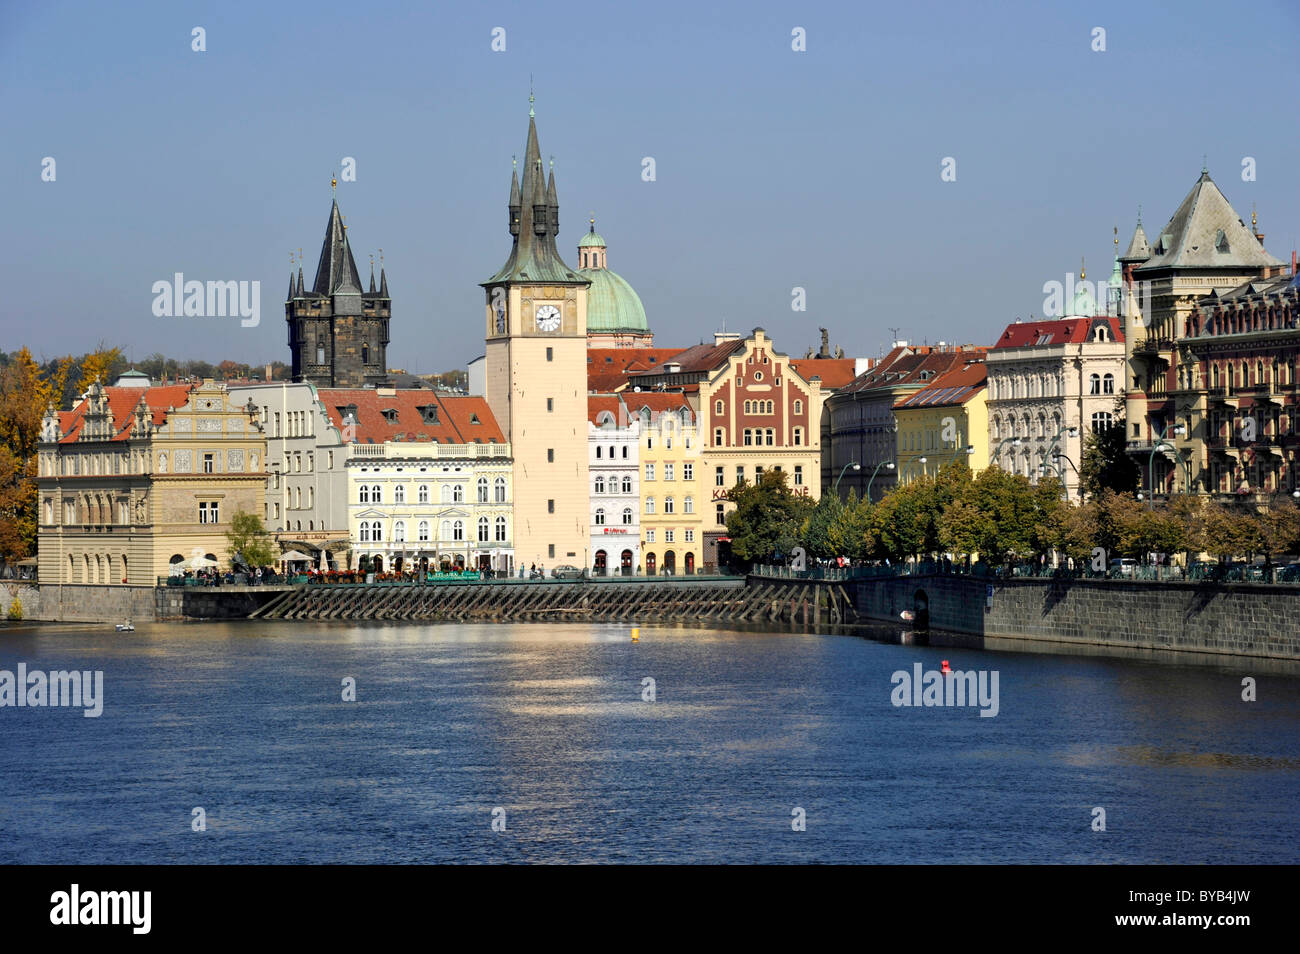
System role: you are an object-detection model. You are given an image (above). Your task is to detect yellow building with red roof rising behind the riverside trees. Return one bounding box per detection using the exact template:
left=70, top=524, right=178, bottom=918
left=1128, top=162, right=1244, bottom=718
left=893, top=354, right=989, bottom=483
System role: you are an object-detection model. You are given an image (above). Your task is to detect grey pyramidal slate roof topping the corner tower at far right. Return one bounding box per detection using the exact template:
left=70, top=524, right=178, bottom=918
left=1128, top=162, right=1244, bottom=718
left=1135, top=172, right=1282, bottom=274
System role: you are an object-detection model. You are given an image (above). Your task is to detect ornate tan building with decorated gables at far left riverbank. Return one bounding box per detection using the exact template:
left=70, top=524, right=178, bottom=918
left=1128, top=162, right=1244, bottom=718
left=38, top=373, right=267, bottom=586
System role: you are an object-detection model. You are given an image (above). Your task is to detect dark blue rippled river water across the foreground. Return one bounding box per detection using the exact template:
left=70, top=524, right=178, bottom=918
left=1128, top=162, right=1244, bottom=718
left=0, top=621, right=1300, bottom=863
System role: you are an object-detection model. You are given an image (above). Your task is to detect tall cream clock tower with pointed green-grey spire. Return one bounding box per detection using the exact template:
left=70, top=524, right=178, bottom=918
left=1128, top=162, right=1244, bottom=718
left=482, top=97, right=592, bottom=569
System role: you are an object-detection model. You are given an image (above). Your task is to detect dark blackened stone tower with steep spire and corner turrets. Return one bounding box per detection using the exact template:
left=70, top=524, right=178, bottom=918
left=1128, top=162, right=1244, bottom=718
left=285, top=200, right=393, bottom=387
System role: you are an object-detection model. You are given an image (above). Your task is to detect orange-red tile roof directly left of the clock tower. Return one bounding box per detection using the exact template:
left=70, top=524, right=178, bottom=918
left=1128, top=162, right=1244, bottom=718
left=317, top=387, right=506, bottom=443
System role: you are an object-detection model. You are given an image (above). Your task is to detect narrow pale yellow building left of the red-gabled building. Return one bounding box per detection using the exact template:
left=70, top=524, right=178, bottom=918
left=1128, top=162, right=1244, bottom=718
left=623, top=391, right=705, bottom=576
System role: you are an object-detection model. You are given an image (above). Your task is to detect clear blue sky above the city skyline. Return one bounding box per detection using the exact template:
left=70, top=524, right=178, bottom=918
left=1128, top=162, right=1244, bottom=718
left=0, top=0, right=1300, bottom=373
